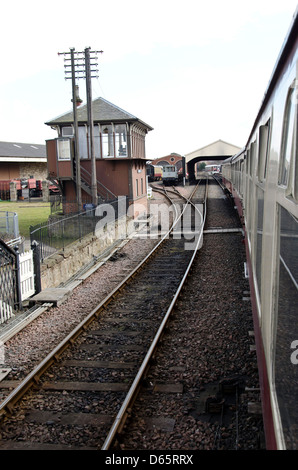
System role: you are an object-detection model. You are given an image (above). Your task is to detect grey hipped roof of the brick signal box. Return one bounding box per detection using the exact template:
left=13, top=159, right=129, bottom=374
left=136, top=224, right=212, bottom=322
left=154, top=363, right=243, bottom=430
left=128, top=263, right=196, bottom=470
left=45, top=98, right=153, bottom=130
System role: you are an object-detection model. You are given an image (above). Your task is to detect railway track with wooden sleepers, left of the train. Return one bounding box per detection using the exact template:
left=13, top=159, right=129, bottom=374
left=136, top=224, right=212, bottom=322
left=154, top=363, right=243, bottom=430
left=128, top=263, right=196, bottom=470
left=0, top=178, right=205, bottom=449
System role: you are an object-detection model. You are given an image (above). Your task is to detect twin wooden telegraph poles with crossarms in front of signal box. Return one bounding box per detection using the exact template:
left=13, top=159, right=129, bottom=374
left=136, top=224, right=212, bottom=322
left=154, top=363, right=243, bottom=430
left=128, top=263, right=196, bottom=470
left=58, top=47, right=103, bottom=208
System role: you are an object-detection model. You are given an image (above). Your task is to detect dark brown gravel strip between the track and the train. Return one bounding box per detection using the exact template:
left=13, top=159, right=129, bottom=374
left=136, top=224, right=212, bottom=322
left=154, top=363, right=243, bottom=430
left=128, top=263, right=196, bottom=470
left=114, top=180, right=262, bottom=452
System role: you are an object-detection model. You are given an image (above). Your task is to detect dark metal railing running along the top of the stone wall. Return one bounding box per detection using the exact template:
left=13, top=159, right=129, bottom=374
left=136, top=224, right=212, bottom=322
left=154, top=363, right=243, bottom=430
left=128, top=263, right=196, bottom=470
left=30, top=198, right=128, bottom=262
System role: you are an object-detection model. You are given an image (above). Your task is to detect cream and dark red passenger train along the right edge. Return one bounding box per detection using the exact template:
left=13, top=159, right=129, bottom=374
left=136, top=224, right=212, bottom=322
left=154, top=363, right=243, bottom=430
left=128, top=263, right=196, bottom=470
left=222, top=10, right=298, bottom=450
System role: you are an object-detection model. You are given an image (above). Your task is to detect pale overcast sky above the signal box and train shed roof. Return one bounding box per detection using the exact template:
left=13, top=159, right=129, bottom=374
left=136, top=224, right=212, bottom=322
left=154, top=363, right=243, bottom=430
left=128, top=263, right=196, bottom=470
left=0, top=0, right=297, bottom=159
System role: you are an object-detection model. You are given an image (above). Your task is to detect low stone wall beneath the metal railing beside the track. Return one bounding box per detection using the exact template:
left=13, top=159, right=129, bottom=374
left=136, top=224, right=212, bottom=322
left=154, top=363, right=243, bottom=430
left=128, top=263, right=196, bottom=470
left=41, top=216, right=134, bottom=290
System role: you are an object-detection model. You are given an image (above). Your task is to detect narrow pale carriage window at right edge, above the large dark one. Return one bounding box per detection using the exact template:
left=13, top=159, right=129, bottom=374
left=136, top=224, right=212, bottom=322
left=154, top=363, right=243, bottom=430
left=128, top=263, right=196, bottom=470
left=278, top=88, right=296, bottom=186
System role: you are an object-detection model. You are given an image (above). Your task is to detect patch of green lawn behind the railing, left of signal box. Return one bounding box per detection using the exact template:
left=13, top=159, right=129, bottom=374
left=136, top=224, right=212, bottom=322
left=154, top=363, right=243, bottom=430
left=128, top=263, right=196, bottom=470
left=0, top=200, right=51, bottom=238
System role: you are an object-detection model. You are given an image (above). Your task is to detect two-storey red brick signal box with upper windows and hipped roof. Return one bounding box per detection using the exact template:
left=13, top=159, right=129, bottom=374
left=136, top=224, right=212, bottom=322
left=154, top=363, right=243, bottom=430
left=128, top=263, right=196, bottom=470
left=46, top=98, right=152, bottom=215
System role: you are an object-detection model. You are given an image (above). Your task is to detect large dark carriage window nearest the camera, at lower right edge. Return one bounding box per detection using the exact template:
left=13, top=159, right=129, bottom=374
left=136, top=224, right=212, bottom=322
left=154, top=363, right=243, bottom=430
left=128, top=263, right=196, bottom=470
left=274, top=206, right=298, bottom=449
